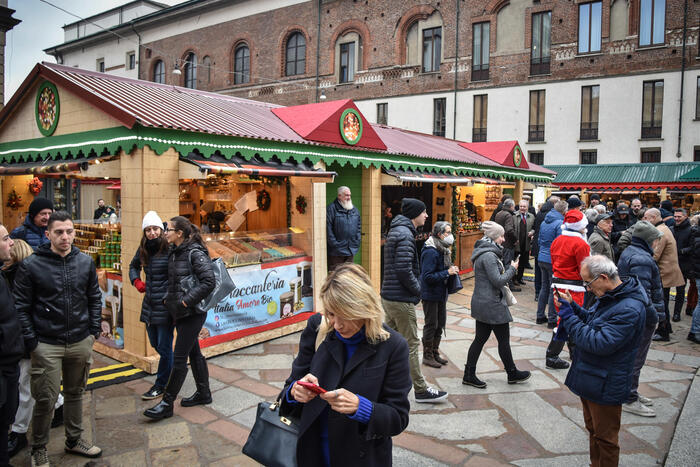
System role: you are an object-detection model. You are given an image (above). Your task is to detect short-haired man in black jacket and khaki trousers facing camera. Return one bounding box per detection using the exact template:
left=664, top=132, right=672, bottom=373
left=14, top=211, right=102, bottom=465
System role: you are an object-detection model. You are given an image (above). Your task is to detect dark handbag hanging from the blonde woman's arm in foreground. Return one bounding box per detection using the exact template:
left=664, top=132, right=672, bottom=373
left=243, top=396, right=299, bottom=467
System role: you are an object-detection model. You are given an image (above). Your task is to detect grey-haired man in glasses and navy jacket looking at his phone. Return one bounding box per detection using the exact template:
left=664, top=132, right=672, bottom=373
left=558, top=255, right=649, bottom=466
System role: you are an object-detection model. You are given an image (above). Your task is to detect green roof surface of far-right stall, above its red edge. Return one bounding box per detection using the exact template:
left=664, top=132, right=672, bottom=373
left=545, top=162, right=700, bottom=185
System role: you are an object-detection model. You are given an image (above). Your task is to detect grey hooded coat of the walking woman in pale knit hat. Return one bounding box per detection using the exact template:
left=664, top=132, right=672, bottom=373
left=471, top=239, right=516, bottom=324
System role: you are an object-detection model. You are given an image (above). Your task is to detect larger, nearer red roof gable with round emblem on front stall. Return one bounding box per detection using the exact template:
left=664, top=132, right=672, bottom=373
left=271, top=99, right=386, bottom=151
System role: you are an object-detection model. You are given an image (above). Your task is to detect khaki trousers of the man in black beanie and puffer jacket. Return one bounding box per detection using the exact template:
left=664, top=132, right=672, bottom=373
left=382, top=298, right=428, bottom=394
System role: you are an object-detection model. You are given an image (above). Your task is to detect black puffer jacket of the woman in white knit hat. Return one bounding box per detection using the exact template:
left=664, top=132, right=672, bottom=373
left=129, top=247, right=173, bottom=326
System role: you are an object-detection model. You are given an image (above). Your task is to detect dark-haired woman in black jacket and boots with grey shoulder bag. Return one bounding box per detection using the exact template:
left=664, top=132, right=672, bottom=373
left=143, top=216, right=216, bottom=420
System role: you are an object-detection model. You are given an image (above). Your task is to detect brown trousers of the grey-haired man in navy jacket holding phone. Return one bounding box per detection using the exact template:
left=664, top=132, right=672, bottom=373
left=581, top=397, right=622, bottom=467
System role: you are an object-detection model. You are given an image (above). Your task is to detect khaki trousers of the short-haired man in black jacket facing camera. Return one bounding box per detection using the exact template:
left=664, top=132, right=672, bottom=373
left=29, top=336, right=95, bottom=449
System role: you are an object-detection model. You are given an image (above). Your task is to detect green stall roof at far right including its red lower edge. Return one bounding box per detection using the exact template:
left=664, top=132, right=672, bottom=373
left=546, top=162, right=700, bottom=190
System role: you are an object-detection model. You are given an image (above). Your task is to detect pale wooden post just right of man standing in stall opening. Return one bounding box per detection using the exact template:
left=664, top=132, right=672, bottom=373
left=360, top=166, right=382, bottom=292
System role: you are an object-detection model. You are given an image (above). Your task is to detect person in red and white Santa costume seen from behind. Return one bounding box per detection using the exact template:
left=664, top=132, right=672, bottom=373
left=546, top=208, right=591, bottom=369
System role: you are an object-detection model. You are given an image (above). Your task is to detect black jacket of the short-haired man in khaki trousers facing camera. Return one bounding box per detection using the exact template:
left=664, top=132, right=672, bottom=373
left=14, top=245, right=102, bottom=350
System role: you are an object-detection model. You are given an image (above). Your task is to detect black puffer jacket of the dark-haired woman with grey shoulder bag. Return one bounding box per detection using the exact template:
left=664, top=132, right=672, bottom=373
left=165, top=240, right=216, bottom=321
